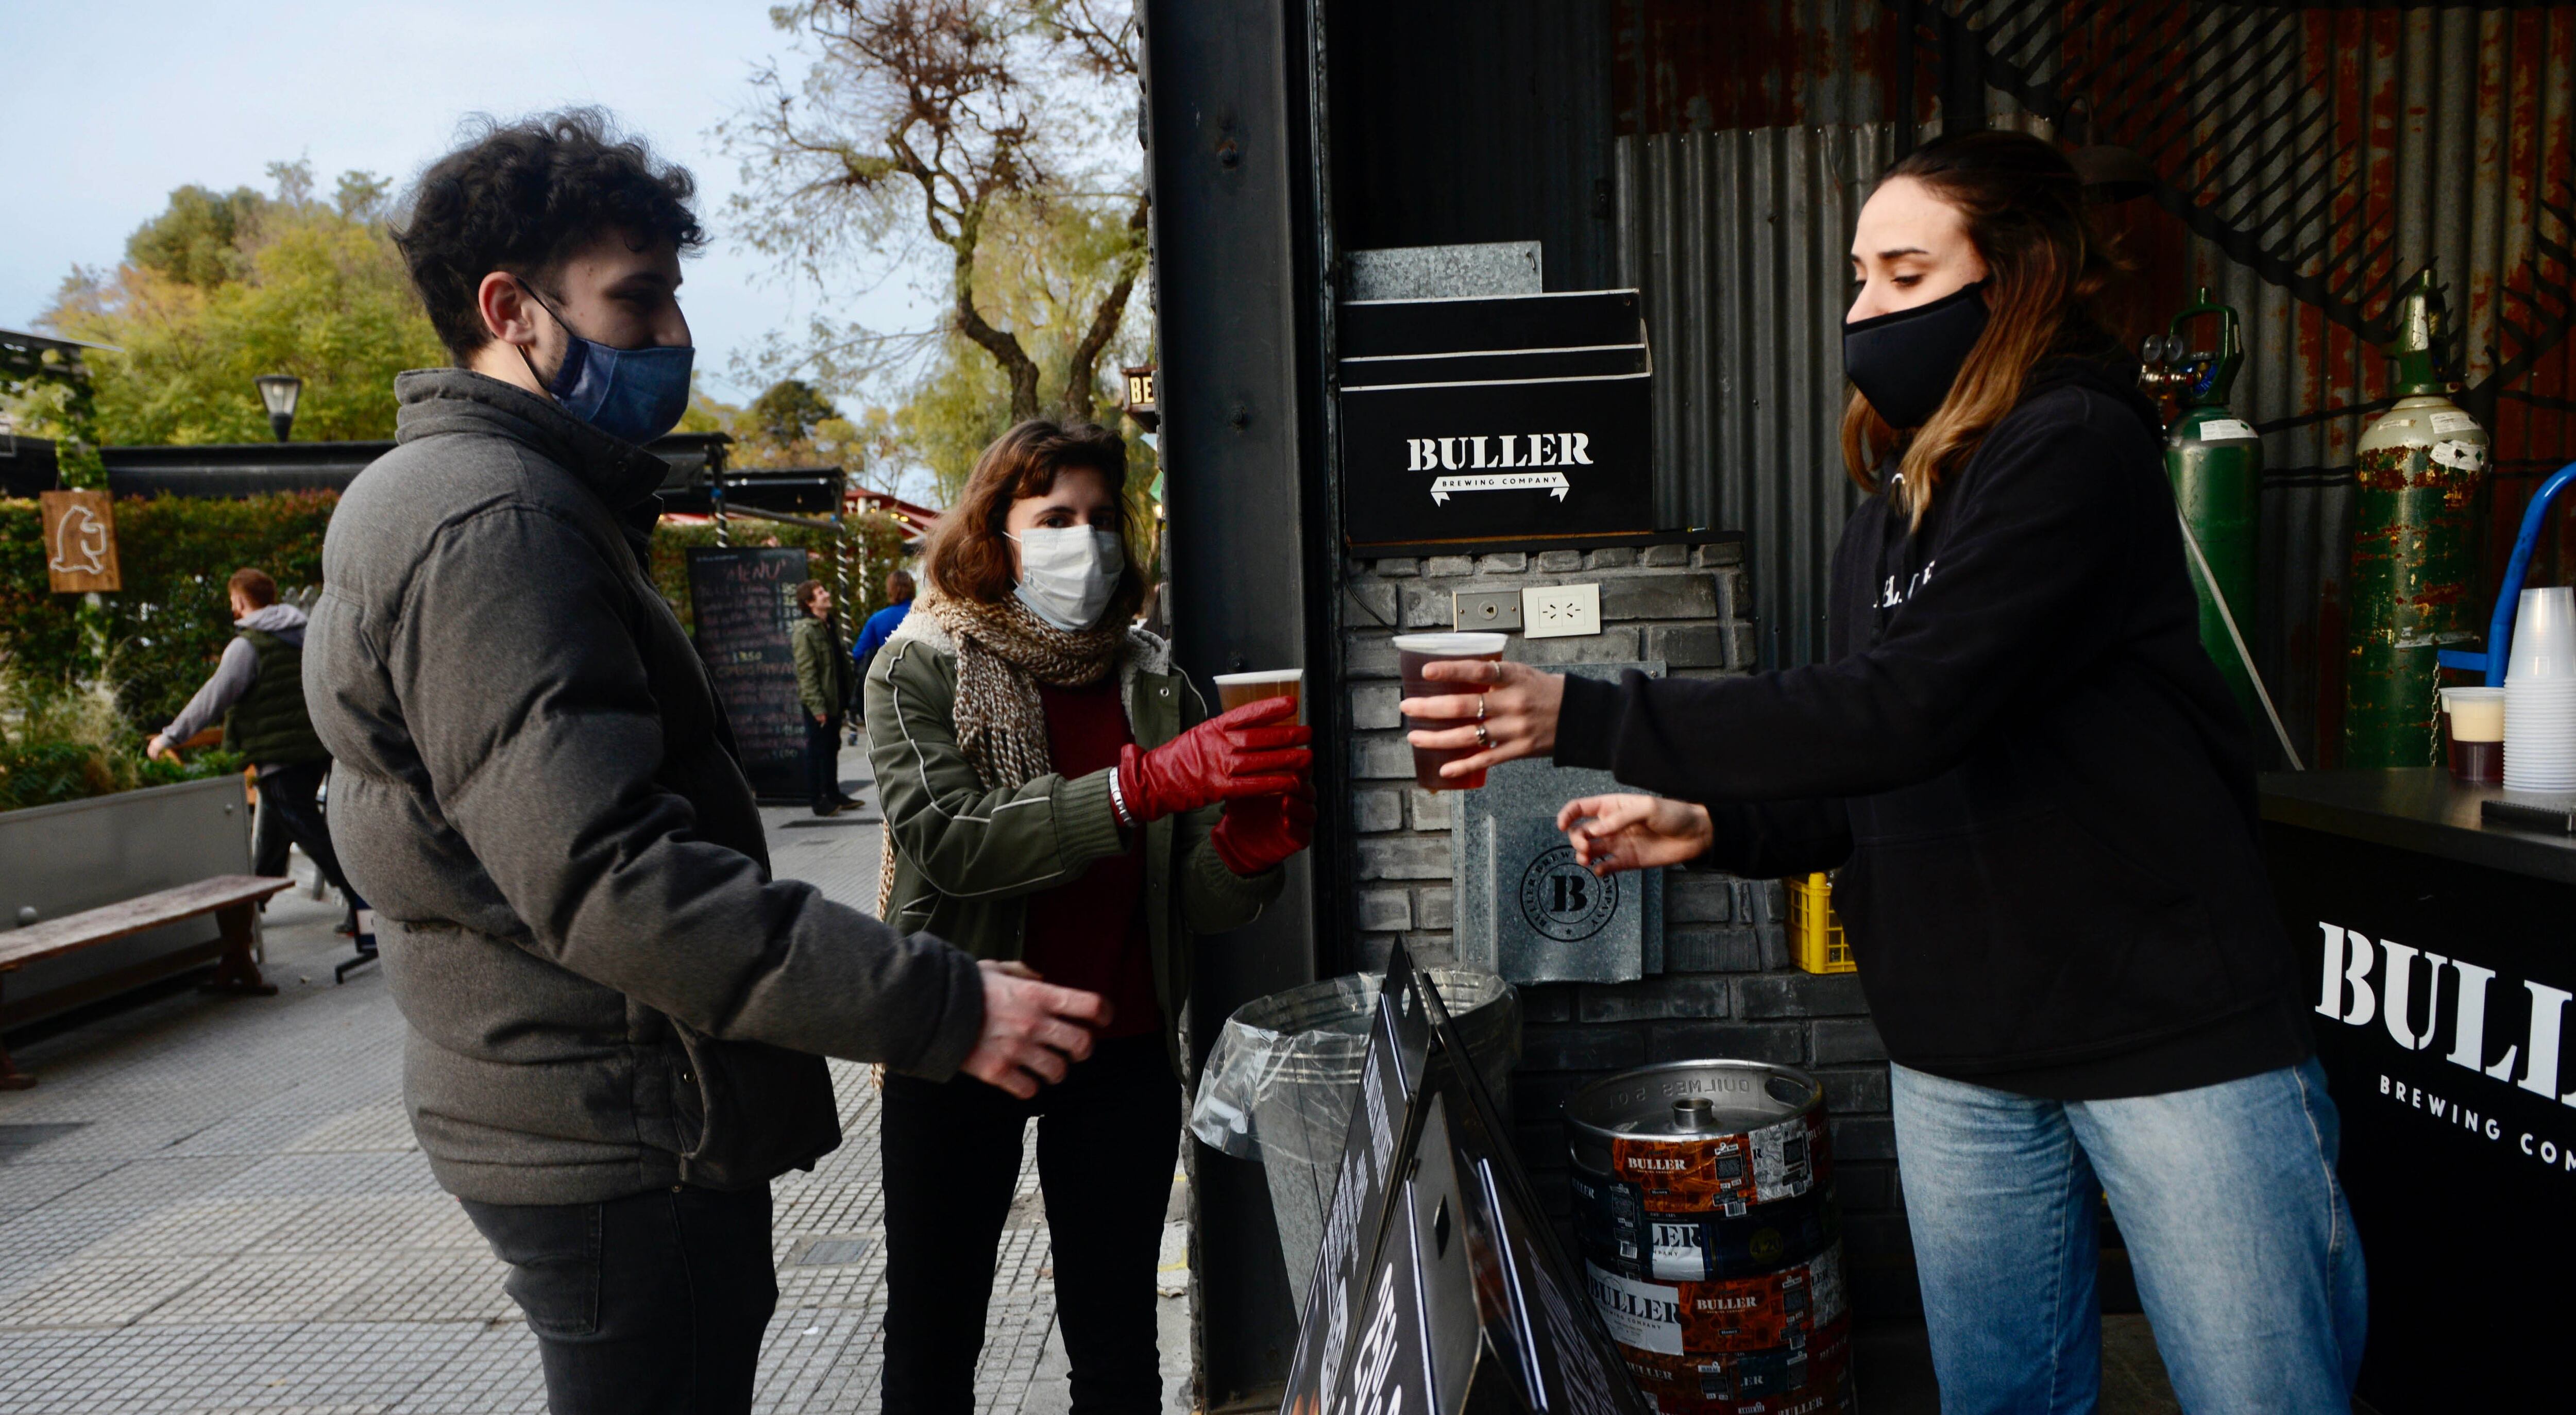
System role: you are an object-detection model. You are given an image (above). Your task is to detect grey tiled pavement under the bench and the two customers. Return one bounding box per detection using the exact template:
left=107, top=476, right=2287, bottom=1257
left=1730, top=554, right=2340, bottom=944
left=0, top=753, right=1190, bottom=1415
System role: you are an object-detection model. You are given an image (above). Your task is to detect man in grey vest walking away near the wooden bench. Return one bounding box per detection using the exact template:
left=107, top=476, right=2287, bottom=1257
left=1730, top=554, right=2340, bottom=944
left=144, top=569, right=358, bottom=933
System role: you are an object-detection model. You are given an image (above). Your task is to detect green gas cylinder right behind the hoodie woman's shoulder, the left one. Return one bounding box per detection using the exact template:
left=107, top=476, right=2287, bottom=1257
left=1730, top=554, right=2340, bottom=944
left=2143, top=286, right=2264, bottom=732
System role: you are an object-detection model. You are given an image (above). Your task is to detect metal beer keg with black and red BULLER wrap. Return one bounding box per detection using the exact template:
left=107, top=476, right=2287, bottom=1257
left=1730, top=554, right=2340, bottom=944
left=1566, top=1062, right=1850, bottom=1415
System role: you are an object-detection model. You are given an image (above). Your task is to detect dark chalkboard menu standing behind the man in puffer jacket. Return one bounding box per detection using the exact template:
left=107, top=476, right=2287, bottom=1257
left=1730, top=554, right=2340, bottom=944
left=688, top=546, right=814, bottom=804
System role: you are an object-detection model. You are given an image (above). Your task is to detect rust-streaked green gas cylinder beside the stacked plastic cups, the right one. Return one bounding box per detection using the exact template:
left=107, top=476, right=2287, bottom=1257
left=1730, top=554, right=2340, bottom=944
left=2344, top=268, right=2486, bottom=768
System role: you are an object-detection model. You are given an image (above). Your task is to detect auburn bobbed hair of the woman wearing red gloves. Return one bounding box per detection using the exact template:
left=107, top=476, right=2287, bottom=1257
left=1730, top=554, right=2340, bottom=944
left=922, top=417, right=1144, bottom=624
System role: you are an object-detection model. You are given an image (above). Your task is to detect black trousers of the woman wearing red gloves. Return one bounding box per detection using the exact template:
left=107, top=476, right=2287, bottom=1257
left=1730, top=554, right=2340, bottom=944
left=884, top=1034, right=1180, bottom=1415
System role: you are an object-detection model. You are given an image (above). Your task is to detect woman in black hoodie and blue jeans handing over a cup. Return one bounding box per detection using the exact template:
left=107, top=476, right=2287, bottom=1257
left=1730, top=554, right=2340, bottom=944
left=1404, top=131, right=2362, bottom=1415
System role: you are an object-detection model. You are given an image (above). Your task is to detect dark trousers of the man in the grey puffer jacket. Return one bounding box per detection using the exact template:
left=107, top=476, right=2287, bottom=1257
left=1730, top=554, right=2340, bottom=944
left=464, top=1186, right=778, bottom=1415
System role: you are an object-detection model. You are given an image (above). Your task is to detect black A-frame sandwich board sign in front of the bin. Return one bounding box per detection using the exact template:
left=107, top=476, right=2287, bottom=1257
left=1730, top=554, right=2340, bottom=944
left=1280, top=944, right=1654, bottom=1415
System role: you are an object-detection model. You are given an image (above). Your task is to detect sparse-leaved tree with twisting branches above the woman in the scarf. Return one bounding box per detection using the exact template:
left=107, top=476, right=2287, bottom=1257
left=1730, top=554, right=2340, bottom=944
left=724, top=0, right=1146, bottom=430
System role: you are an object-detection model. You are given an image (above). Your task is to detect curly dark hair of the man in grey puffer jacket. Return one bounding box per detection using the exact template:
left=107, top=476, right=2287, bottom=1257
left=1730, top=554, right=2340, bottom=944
left=394, top=108, right=706, bottom=363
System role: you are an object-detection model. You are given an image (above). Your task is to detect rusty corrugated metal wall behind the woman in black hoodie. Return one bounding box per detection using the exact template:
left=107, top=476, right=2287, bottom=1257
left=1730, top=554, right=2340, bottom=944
left=1610, top=0, right=2576, bottom=761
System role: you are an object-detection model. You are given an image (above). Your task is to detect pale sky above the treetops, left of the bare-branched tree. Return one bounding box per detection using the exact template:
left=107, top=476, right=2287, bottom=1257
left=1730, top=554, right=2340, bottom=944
left=0, top=0, right=938, bottom=402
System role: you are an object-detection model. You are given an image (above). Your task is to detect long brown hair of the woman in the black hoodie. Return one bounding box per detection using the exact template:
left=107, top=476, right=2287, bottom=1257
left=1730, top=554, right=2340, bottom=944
left=1842, top=131, right=2123, bottom=526
